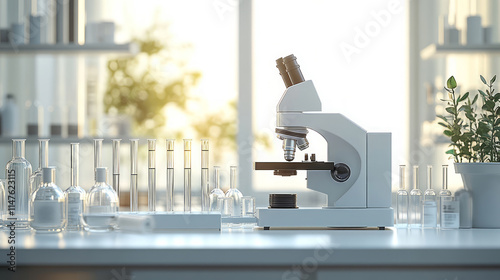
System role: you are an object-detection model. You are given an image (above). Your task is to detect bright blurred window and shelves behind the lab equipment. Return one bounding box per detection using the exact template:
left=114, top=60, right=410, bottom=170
left=0, top=0, right=500, bottom=210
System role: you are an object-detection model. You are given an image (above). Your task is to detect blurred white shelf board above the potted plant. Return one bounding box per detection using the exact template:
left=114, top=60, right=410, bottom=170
left=420, top=44, right=500, bottom=60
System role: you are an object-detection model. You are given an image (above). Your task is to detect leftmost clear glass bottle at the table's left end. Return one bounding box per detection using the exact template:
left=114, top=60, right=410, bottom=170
left=4, top=139, right=31, bottom=229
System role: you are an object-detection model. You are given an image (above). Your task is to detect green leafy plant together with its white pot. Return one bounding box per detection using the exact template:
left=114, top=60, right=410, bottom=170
left=437, top=76, right=500, bottom=228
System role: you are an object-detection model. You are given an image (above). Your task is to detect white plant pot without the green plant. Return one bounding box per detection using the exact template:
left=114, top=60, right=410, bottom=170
left=455, top=162, right=500, bottom=228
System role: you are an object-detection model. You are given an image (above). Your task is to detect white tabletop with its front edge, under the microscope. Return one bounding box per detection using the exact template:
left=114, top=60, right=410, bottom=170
left=0, top=228, right=500, bottom=266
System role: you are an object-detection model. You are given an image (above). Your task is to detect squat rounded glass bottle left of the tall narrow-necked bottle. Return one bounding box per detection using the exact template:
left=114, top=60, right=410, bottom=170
left=30, top=167, right=65, bottom=232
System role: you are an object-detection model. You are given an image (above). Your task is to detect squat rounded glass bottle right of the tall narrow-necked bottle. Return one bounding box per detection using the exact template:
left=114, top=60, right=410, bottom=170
left=84, top=167, right=118, bottom=232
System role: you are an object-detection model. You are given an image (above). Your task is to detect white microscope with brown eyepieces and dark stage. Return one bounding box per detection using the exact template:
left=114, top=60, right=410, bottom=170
left=255, top=54, right=394, bottom=229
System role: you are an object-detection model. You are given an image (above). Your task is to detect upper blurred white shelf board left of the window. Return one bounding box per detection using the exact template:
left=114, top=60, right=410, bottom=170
left=0, top=43, right=139, bottom=55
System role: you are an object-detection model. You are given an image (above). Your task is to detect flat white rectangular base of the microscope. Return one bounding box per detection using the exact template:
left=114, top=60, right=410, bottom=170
left=257, top=207, right=394, bottom=229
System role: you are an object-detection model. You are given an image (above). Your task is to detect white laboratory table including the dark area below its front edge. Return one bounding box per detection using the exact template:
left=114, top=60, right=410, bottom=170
left=0, top=228, right=500, bottom=280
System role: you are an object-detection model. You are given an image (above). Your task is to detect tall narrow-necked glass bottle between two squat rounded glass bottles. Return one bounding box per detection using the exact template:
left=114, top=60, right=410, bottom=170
left=65, top=143, right=87, bottom=231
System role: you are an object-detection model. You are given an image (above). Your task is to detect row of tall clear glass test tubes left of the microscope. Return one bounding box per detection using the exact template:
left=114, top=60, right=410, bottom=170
left=94, top=139, right=210, bottom=212
